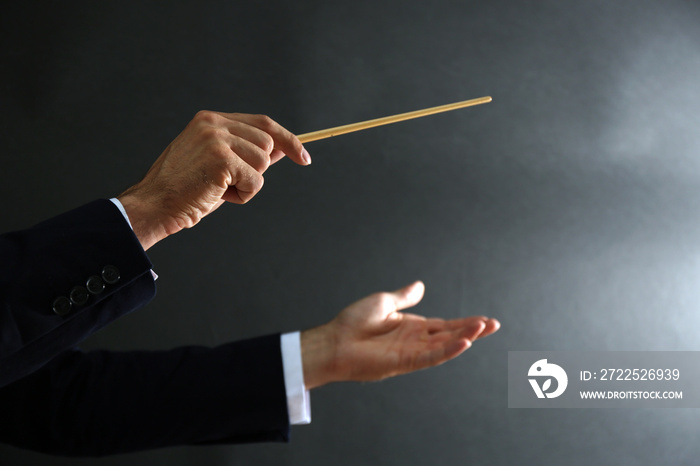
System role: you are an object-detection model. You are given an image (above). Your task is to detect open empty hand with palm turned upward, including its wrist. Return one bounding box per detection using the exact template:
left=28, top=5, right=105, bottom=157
left=301, top=282, right=500, bottom=389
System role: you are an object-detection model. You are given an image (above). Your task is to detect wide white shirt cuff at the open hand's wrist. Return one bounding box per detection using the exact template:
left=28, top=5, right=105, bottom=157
left=280, top=332, right=311, bottom=425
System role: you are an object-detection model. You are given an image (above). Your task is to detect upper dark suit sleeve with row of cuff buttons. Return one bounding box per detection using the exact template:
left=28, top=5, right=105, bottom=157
left=0, top=200, right=155, bottom=387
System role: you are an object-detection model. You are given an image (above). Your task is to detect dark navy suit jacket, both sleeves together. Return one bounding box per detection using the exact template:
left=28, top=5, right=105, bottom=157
left=0, top=200, right=289, bottom=456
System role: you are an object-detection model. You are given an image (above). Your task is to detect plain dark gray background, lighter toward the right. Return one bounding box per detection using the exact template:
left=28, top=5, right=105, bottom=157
left=0, top=0, right=700, bottom=465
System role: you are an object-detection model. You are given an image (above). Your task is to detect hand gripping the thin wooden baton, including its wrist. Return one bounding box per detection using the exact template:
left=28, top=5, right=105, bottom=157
left=118, top=111, right=311, bottom=249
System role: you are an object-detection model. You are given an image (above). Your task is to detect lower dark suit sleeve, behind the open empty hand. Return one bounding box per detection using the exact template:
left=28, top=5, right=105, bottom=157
left=0, top=335, right=289, bottom=456
